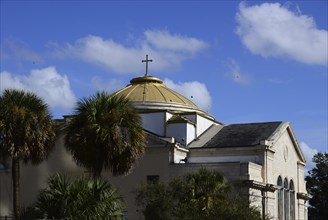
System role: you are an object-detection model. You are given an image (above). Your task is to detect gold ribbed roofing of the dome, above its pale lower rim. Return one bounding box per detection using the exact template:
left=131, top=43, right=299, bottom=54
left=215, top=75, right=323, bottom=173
left=114, top=76, right=198, bottom=108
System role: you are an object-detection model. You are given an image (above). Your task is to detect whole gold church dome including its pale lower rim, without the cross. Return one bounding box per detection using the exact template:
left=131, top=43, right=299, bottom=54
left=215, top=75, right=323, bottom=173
left=113, top=75, right=213, bottom=115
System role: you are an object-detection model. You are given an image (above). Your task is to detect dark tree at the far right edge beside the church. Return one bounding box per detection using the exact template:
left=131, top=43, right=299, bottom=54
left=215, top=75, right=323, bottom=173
left=305, top=153, right=328, bottom=220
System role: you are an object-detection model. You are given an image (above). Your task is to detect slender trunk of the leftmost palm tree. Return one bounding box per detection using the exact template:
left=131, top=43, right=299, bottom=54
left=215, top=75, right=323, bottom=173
left=12, top=158, right=20, bottom=219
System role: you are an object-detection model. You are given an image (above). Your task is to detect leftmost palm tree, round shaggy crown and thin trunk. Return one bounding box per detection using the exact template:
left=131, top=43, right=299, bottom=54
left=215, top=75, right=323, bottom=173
left=0, top=90, right=55, bottom=218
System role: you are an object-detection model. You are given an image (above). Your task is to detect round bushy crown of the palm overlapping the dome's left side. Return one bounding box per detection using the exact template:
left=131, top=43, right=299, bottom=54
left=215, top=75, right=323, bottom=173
left=65, top=92, right=146, bottom=178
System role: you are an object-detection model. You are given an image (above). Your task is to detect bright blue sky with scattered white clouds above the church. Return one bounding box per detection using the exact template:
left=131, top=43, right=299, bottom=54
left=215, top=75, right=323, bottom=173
left=0, top=0, right=328, bottom=170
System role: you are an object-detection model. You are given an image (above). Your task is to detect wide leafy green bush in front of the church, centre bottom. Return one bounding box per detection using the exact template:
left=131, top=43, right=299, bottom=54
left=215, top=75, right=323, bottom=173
left=136, top=169, right=261, bottom=220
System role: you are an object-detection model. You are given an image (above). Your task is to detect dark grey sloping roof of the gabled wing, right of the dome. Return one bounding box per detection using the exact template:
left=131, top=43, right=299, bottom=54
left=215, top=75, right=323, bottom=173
left=202, top=122, right=283, bottom=148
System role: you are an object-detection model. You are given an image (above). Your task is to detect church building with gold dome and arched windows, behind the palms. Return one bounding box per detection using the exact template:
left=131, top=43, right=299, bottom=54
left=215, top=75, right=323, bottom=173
left=0, top=60, right=309, bottom=220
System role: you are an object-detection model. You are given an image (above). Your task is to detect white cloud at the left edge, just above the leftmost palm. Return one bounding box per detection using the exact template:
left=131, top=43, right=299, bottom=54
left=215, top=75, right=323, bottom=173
left=0, top=67, right=76, bottom=109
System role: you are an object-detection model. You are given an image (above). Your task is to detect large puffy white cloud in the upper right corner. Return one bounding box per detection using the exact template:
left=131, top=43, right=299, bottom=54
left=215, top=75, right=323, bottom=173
left=236, top=2, right=328, bottom=65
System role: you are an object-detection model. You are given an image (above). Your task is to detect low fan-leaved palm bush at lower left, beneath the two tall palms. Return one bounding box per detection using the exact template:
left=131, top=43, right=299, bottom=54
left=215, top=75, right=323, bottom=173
left=22, top=174, right=123, bottom=220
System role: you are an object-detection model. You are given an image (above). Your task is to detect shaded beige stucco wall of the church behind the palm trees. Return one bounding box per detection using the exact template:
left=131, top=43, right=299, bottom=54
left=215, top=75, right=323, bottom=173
left=0, top=140, right=170, bottom=219
